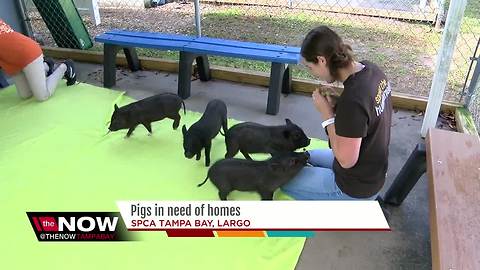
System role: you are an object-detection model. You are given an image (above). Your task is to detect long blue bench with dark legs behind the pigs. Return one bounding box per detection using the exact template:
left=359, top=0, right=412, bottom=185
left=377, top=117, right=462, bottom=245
left=95, top=30, right=300, bottom=115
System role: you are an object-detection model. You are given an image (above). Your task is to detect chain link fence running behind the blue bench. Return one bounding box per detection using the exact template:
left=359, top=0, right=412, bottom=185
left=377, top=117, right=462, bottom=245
left=24, top=0, right=480, bottom=131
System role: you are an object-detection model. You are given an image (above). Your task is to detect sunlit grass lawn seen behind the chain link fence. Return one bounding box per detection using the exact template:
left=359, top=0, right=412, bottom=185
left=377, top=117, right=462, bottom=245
left=88, top=4, right=480, bottom=100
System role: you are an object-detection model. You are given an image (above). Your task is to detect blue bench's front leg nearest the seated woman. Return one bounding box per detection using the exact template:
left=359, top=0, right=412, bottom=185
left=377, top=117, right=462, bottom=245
left=267, top=63, right=285, bottom=115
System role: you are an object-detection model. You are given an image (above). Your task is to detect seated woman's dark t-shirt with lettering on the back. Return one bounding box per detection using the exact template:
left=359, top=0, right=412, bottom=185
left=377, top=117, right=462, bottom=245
left=333, top=61, right=392, bottom=198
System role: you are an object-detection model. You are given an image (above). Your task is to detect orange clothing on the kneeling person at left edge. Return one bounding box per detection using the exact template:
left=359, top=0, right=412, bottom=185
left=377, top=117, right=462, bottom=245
left=0, top=19, right=42, bottom=76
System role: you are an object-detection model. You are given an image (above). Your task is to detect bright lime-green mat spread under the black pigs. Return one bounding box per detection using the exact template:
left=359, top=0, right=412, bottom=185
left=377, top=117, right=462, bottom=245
left=0, top=84, right=324, bottom=270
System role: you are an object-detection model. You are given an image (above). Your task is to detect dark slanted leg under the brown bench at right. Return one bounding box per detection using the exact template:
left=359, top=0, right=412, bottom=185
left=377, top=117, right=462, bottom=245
left=383, top=143, right=427, bottom=206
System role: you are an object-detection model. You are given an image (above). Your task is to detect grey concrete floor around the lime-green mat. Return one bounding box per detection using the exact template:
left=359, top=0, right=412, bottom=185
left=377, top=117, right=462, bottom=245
left=77, top=63, right=431, bottom=270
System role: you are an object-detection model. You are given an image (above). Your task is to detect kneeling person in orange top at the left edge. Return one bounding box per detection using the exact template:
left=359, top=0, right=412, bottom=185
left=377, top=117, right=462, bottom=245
left=0, top=19, right=77, bottom=101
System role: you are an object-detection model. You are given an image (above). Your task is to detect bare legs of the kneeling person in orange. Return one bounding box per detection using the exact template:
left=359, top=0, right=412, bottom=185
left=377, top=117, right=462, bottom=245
left=23, top=55, right=67, bottom=101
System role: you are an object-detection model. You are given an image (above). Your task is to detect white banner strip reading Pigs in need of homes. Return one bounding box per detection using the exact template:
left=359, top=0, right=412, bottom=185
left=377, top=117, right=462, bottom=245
left=117, top=201, right=390, bottom=230
